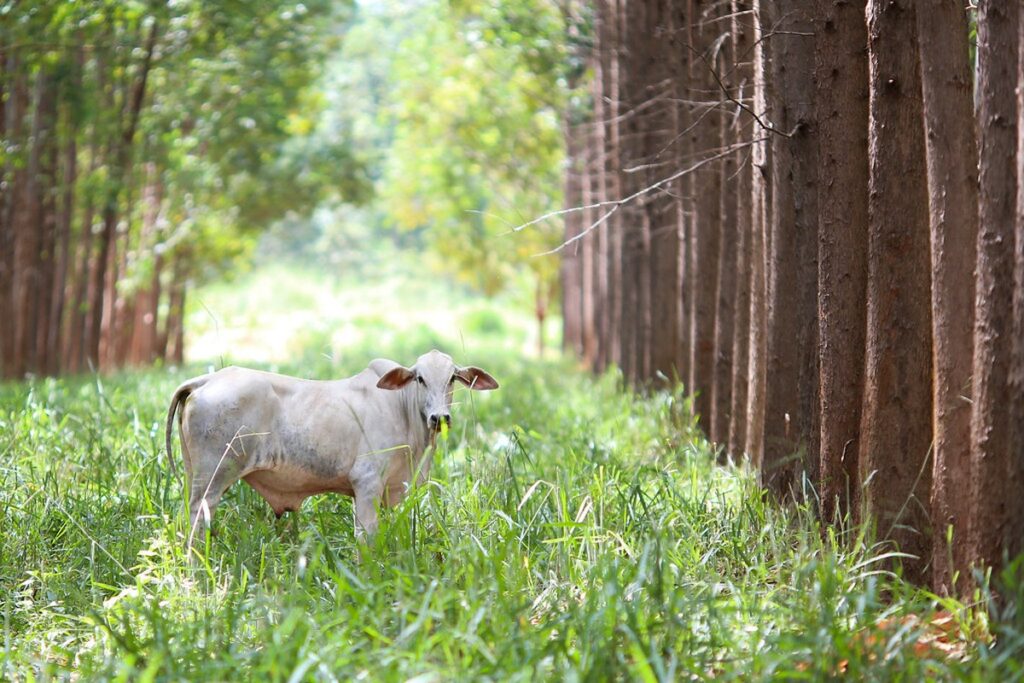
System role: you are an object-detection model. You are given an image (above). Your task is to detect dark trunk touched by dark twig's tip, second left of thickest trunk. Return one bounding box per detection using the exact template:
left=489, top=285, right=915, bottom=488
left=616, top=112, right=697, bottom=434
left=761, top=0, right=818, bottom=497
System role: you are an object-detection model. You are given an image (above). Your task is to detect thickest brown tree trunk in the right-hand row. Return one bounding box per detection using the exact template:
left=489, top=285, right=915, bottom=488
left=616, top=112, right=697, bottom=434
left=859, top=0, right=932, bottom=583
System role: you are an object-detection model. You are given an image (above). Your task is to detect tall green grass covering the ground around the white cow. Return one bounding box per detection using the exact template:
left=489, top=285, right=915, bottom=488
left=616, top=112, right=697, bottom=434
left=0, top=264, right=1024, bottom=681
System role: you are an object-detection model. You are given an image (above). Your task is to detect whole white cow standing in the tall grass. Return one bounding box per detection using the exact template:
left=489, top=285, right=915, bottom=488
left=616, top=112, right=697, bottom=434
left=167, top=350, right=498, bottom=549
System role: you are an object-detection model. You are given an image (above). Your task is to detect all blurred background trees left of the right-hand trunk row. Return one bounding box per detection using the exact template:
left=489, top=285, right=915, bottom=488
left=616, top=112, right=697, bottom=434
left=0, top=0, right=579, bottom=377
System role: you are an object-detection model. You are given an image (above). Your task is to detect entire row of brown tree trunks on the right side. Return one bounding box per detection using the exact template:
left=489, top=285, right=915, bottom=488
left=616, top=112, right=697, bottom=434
left=562, top=0, right=1024, bottom=592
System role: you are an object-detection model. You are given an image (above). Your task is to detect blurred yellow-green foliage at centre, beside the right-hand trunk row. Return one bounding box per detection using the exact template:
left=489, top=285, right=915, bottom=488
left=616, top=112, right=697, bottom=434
left=319, top=0, right=571, bottom=294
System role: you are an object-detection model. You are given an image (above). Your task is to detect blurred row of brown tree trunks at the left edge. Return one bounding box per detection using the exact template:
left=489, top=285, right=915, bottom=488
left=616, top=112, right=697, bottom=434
left=0, top=34, right=186, bottom=378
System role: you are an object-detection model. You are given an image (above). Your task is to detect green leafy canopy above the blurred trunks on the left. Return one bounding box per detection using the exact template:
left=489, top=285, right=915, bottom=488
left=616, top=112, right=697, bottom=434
left=0, top=0, right=370, bottom=287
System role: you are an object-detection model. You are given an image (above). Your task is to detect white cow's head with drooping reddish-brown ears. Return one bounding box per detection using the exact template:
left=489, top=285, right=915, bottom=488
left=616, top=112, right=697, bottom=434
left=377, top=349, right=498, bottom=431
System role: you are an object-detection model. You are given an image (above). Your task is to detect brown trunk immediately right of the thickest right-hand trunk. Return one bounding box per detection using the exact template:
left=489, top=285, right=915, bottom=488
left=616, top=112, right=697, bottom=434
left=918, top=0, right=978, bottom=593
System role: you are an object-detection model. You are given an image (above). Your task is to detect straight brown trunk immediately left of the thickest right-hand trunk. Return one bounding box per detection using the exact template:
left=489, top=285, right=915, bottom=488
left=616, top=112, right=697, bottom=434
left=814, top=0, right=868, bottom=523
